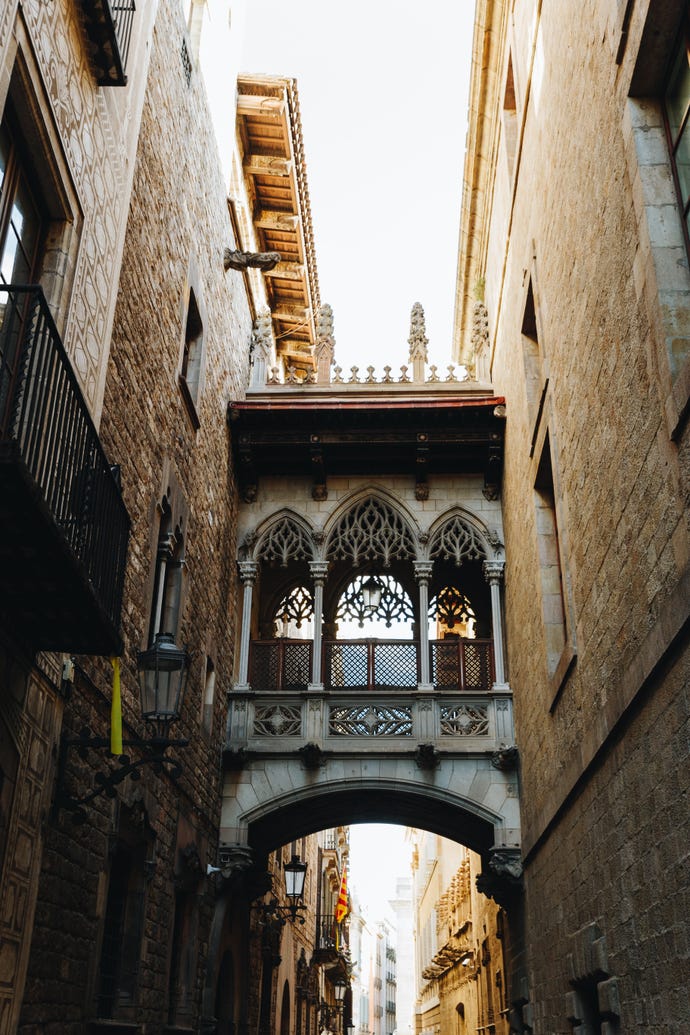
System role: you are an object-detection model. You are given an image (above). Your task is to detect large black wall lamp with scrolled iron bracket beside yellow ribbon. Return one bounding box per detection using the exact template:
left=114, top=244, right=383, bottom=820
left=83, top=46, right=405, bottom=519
left=54, top=632, right=189, bottom=823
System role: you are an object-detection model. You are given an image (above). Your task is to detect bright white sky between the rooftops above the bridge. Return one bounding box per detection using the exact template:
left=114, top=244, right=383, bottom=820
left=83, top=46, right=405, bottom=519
left=241, top=0, right=475, bottom=373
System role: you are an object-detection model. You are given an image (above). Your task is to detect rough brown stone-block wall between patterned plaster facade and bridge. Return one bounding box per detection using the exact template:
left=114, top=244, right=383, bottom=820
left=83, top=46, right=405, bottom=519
left=19, top=0, right=251, bottom=1033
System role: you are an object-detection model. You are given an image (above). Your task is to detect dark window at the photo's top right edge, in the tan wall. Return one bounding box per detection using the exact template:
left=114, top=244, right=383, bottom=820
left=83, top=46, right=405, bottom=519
left=664, top=16, right=690, bottom=249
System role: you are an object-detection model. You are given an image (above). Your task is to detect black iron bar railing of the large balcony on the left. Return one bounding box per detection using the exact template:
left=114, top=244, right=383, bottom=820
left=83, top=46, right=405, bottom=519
left=0, top=285, right=129, bottom=628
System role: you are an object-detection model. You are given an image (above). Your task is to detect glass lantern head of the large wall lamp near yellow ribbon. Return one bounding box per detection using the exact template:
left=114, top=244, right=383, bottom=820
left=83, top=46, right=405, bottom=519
left=137, top=632, right=189, bottom=739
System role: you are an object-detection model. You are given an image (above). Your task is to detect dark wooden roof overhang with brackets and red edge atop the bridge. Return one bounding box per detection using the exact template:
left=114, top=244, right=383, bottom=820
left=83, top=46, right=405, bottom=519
left=229, top=395, right=505, bottom=501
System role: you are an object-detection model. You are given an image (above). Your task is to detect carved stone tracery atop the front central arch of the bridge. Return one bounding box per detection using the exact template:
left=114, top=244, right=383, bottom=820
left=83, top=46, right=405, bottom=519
left=327, top=496, right=415, bottom=568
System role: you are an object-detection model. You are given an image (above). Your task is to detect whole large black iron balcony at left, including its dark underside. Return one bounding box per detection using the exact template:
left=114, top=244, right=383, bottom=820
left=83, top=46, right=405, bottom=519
left=0, top=286, right=129, bottom=654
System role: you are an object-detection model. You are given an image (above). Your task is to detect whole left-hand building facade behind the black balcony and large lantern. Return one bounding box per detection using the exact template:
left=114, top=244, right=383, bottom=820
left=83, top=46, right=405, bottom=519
left=0, top=2, right=261, bottom=1035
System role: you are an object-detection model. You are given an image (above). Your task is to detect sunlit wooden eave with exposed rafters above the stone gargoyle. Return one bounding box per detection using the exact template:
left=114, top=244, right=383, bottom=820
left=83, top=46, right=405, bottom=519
left=237, top=76, right=320, bottom=368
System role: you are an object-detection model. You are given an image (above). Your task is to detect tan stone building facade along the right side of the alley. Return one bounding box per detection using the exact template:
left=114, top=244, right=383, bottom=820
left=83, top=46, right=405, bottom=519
left=456, top=0, right=690, bottom=1033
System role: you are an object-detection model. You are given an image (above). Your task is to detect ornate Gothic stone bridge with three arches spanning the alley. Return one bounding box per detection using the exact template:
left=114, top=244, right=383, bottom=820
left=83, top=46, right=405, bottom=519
left=221, top=302, right=519, bottom=894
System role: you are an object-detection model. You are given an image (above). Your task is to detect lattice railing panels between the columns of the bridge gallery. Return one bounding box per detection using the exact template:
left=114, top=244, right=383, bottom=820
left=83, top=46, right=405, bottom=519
left=249, top=639, right=494, bottom=692
